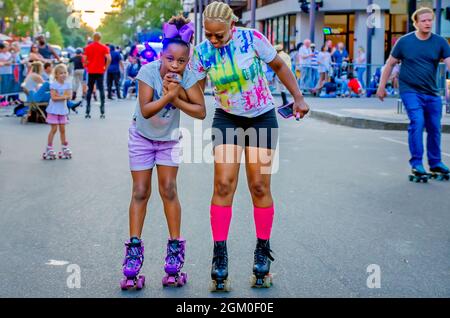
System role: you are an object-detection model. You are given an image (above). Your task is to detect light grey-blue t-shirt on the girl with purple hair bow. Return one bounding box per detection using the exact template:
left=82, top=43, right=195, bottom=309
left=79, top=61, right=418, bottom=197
left=134, top=60, right=197, bottom=141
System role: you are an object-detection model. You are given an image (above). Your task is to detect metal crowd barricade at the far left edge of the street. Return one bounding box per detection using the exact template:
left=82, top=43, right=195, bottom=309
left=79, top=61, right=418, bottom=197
left=0, top=64, right=26, bottom=97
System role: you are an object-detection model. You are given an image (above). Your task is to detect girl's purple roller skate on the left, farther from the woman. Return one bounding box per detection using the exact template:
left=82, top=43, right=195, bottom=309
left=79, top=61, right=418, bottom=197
left=120, top=238, right=145, bottom=290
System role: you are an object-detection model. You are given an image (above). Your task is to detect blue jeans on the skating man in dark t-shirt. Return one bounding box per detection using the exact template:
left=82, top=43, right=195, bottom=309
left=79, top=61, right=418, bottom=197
left=400, top=92, right=442, bottom=168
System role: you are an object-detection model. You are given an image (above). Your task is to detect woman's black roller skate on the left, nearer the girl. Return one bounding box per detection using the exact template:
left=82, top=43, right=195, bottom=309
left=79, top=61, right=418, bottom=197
left=210, top=241, right=231, bottom=292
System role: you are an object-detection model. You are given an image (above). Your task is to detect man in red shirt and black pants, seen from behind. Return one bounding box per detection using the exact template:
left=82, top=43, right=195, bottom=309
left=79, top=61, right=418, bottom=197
left=84, top=32, right=111, bottom=118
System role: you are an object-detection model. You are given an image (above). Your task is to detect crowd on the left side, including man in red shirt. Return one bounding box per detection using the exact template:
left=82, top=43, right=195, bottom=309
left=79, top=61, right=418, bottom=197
left=0, top=34, right=158, bottom=113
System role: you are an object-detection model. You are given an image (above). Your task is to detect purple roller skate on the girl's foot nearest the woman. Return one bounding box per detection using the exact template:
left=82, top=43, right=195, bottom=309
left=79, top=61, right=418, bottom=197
left=162, top=238, right=187, bottom=287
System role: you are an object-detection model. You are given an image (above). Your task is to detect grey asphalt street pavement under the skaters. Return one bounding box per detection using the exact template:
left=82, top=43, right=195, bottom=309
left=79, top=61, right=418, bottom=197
left=0, top=96, right=450, bottom=298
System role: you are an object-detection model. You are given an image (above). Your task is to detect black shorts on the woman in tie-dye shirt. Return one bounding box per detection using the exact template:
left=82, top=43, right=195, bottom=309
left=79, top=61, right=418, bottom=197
left=212, top=108, right=278, bottom=149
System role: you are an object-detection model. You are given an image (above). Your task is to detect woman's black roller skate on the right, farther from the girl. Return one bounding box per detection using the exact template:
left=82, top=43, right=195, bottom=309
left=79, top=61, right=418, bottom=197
left=251, top=239, right=274, bottom=288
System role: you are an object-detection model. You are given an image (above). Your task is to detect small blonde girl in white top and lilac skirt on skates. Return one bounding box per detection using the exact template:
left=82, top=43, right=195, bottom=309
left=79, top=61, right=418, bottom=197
left=42, top=64, right=72, bottom=160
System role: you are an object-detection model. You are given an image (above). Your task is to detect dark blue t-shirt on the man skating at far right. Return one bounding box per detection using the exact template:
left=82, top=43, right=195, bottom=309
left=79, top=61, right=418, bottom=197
left=391, top=32, right=450, bottom=96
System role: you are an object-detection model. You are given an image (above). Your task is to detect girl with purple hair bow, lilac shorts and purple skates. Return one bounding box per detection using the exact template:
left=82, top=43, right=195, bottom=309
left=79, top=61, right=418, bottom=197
left=120, top=17, right=205, bottom=289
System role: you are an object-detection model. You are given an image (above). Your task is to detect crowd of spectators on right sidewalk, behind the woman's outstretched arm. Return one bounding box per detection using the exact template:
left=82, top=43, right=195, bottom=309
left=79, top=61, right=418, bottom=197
left=268, top=39, right=400, bottom=98
